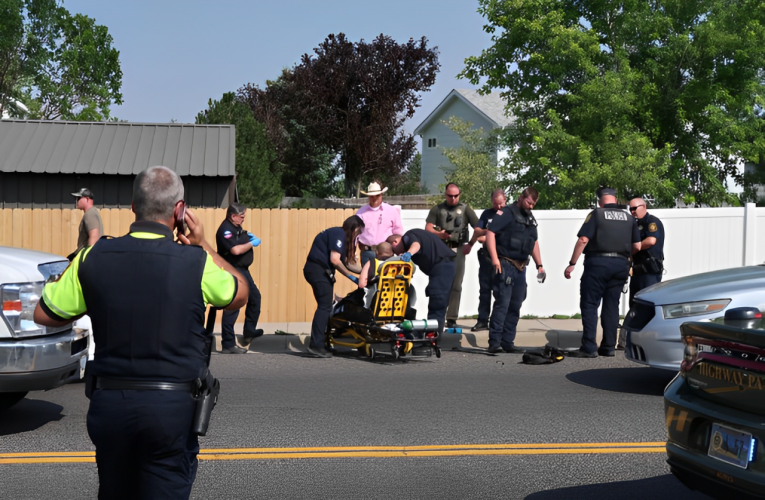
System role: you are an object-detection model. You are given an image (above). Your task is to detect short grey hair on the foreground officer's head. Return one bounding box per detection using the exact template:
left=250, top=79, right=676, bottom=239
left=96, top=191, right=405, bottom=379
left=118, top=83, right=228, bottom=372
left=133, top=167, right=183, bottom=221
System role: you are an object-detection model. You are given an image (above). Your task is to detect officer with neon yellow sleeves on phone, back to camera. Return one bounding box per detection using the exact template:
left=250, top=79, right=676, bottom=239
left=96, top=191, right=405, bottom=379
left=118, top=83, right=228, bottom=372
left=34, top=167, right=249, bottom=499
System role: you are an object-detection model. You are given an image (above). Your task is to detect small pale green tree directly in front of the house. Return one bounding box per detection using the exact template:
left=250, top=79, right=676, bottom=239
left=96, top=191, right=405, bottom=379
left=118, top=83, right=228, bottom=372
left=435, top=116, right=504, bottom=209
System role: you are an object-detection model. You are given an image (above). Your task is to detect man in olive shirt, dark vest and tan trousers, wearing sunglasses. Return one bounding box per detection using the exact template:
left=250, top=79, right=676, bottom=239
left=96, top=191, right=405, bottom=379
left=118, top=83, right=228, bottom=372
left=425, top=182, right=478, bottom=328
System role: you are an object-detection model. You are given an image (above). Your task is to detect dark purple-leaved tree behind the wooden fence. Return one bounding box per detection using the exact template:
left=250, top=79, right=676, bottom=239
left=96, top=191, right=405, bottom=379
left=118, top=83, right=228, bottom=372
left=239, top=33, right=439, bottom=195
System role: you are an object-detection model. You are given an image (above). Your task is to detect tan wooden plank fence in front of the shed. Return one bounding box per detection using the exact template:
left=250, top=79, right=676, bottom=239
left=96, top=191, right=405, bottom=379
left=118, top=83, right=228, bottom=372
left=0, top=208, right=356, bottom=323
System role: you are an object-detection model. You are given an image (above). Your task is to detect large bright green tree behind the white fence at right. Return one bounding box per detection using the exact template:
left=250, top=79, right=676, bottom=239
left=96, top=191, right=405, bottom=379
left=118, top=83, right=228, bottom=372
left=461, top=0, right=765, bottom=208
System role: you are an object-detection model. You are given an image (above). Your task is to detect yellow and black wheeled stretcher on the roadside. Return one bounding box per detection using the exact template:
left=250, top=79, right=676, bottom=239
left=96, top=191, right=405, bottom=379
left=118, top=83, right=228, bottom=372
left=325, top=261, right=441, bottom=359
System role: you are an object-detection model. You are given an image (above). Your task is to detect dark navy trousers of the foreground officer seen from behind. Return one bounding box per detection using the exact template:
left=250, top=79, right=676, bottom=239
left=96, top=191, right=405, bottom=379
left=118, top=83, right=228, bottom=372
left=88, top=389, right=199, bottom=500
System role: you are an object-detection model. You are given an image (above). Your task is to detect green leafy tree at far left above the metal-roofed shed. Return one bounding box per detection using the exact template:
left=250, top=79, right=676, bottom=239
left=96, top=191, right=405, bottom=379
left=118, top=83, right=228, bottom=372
left=0, top=0, right=122, bottom=121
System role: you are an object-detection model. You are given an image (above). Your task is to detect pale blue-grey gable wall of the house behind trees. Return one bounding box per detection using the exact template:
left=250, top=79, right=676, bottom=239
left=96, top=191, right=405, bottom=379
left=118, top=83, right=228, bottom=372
left=420, top=97, right=493, bottom=194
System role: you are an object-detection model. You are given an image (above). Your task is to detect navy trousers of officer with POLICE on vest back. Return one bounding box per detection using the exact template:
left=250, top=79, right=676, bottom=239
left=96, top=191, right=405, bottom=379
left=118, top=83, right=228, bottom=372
left=579, top=256, right=630, bottom=353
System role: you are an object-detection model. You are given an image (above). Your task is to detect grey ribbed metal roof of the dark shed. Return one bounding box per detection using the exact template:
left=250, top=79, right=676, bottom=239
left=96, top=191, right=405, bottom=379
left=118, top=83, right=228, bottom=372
left=0, top=120, right=236, bottom=177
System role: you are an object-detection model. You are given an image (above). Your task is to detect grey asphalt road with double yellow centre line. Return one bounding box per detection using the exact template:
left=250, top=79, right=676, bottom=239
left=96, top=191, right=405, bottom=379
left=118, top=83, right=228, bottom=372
left=0, top=352, right=705, bottom=500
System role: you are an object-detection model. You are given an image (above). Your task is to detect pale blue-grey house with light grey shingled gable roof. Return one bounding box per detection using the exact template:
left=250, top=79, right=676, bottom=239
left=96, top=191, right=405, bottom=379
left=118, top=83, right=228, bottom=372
left=414, top=89, right=513, bottom=193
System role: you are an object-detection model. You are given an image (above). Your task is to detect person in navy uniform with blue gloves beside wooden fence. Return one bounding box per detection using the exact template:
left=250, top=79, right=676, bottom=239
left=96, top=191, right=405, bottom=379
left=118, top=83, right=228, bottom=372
left=215, top=203, right=263, bottom=354
